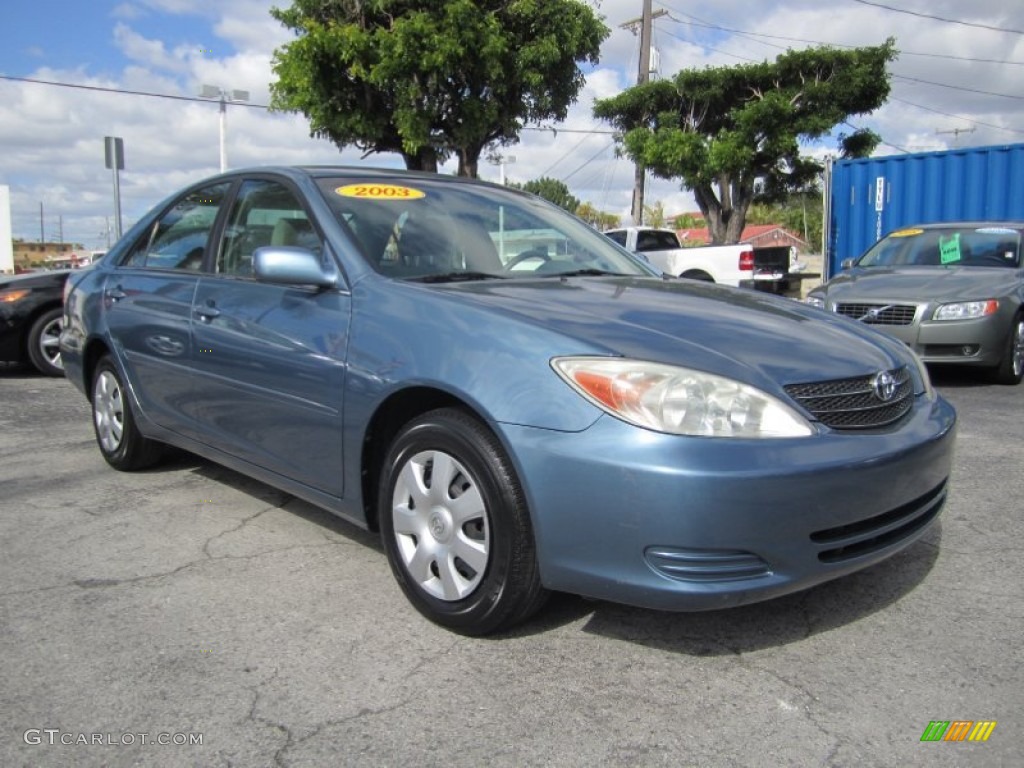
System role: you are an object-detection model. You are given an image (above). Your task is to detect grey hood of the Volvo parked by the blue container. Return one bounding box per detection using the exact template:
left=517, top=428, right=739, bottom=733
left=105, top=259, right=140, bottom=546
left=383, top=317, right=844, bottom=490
left=824, top=266, right=1020, bottom=302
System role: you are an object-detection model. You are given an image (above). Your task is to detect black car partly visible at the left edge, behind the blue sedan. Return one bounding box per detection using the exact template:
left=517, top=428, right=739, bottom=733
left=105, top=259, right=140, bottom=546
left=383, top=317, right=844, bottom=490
left=0, top=269, right=69, bottom=376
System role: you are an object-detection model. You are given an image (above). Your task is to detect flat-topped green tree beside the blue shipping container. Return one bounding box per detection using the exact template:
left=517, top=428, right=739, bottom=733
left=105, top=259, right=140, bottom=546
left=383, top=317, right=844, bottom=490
left=594, top=39, right=896, bottom=243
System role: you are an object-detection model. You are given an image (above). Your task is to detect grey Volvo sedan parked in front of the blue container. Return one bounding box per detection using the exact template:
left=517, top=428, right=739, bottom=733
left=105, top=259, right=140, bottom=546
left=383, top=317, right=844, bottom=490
left=807, top=221, right=1024, bottom=384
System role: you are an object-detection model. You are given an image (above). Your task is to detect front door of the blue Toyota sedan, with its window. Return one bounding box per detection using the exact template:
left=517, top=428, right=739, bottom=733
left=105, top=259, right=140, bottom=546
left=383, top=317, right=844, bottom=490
left=193, top=178, right=351, bottom=497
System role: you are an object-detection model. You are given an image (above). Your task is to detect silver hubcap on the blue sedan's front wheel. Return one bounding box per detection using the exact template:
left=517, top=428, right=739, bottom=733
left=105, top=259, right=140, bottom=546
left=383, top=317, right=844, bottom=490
left=391, top=451, right=490, bottom=601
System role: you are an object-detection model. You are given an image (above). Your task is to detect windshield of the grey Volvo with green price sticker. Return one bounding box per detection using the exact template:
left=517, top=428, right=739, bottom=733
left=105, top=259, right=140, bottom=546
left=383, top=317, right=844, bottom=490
left=857, top=226, right=1021, bottom=267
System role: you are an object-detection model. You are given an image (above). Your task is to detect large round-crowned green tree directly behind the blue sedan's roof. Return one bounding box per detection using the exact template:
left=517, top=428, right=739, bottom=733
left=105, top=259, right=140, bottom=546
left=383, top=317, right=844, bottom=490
left=270, top=0, right=608, bottom=177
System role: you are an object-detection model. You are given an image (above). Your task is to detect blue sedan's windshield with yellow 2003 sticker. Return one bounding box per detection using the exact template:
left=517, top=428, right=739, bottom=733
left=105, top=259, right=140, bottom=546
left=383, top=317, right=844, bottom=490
left=317, top=177, right=653, bottom=283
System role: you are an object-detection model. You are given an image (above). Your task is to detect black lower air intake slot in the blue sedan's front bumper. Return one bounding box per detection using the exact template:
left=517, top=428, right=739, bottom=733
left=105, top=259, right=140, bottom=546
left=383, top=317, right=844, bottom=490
left=811, top=481, right=946, bottom=563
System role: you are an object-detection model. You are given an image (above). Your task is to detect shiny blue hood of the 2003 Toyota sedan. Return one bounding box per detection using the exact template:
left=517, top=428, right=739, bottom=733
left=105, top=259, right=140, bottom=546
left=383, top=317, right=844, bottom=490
left=435, top=278, right=909, bottom=389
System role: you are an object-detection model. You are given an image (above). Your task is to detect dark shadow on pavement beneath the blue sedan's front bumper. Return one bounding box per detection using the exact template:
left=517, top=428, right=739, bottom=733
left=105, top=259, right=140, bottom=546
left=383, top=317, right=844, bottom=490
left=512, top=522, right=941, bottom=656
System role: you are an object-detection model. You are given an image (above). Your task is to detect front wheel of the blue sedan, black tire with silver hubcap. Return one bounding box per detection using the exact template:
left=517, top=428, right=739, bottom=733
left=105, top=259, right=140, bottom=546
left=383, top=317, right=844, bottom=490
left=378, top=409, right=547, bottom=636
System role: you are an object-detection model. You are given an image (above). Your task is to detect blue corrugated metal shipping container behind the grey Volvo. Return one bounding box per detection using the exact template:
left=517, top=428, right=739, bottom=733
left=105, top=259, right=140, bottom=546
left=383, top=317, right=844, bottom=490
left=825, top=144, right=1024, bottom=276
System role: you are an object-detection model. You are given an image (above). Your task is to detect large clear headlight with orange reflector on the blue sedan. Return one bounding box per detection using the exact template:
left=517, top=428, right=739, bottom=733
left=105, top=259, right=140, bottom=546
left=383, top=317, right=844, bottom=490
left=551, top=357, right=814, bottom=438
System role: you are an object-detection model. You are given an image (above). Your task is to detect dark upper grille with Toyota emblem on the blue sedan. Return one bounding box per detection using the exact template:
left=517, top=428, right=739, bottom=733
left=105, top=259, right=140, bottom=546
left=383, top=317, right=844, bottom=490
left=785, top=367, right=913, bottom=429
